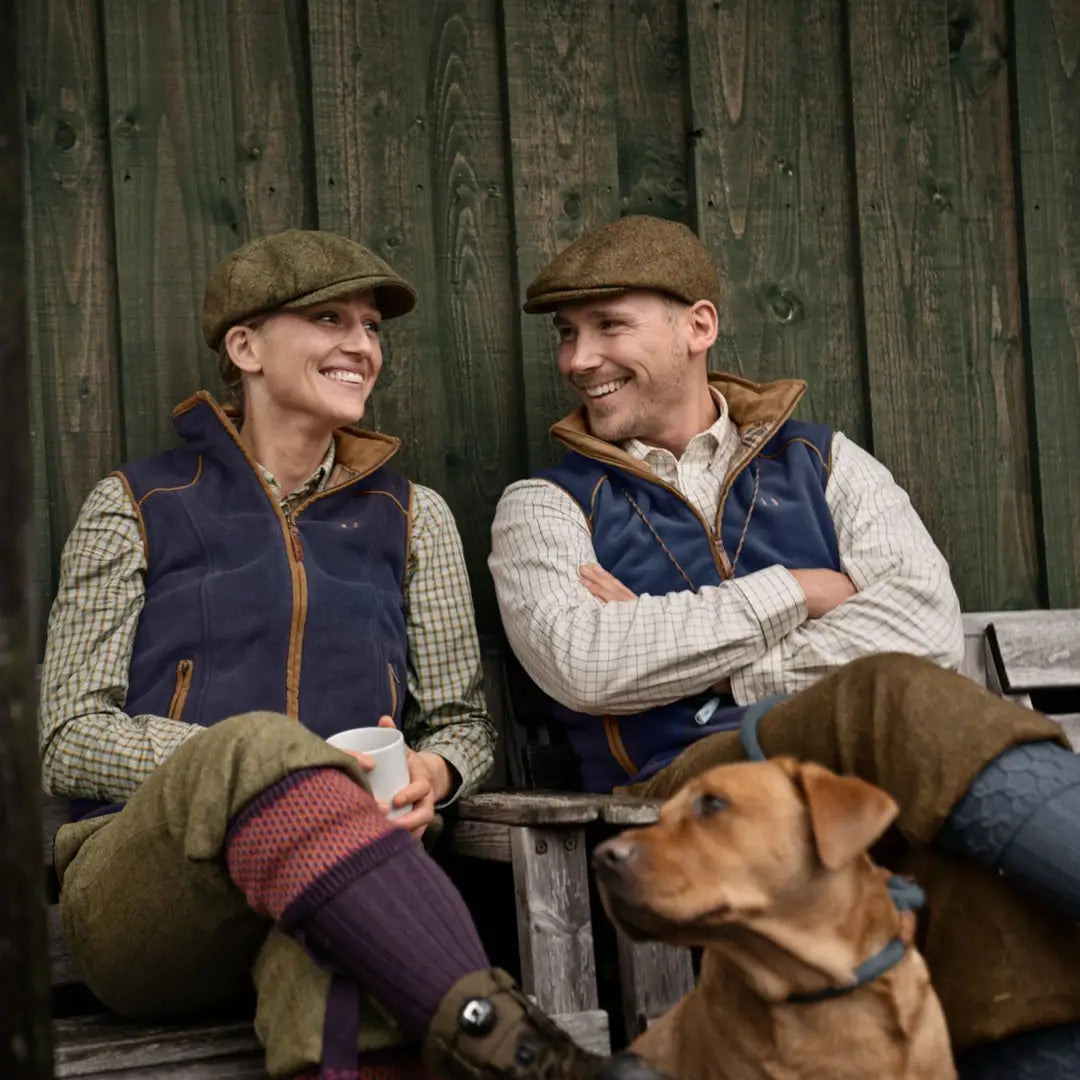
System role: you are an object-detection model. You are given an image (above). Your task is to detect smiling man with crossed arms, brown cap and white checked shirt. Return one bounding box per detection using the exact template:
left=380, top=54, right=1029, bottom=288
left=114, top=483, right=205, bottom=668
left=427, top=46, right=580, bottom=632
left=490, top=217, right=1080, bottom=1077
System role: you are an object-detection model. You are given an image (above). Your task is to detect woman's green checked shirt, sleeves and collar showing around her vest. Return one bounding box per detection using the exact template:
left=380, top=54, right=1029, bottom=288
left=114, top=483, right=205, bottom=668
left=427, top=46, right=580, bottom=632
left=38, top=442, right=495, bottom=802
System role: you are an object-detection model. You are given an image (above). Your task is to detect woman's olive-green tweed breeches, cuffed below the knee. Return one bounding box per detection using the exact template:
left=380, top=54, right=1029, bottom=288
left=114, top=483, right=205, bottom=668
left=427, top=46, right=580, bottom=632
left=55, top=713, right=408, bottom=1077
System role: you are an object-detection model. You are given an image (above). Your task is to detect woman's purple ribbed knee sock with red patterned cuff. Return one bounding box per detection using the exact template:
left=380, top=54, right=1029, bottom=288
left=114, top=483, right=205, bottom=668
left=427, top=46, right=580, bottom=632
left=226, top=769, right=490, bottom=1035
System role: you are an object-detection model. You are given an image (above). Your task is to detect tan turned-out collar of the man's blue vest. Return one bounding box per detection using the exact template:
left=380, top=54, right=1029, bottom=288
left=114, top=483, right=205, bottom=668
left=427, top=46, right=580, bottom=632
left=551, top=372, right=807, bottom=480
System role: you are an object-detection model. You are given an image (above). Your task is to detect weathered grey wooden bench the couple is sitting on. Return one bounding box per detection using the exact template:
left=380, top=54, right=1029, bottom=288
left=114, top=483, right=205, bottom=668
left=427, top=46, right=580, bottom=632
left=44, top=611, right=1080, bottom=1080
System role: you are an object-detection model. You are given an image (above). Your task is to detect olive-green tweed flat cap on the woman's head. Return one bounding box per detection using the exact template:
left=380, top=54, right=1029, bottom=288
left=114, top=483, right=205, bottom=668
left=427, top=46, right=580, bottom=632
left=202, top=229, right=416, bottom=349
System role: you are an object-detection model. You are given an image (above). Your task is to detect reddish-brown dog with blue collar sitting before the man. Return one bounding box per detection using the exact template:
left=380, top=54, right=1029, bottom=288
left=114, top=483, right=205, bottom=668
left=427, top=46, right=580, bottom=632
left=593, top=758, right=956, bottom=1080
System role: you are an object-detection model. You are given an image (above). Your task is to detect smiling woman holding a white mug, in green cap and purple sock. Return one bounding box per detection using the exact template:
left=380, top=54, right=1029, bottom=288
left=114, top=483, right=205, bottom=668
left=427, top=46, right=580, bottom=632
left=41, top=230, right=656, bottom=1077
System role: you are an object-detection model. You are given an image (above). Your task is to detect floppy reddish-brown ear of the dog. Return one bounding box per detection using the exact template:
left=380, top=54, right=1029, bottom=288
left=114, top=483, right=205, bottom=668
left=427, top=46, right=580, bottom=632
left=799, top=761, right=899, bottom=870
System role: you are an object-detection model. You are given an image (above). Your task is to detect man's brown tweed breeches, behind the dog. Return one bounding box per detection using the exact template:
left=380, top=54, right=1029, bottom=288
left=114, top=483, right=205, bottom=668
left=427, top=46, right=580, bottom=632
left=627, top=653, right=1080, bottom=1051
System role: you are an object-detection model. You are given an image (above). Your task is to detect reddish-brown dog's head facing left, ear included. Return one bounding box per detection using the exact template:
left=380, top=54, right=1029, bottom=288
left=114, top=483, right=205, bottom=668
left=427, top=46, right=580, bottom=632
left=593, top=757, right=897, bottom=945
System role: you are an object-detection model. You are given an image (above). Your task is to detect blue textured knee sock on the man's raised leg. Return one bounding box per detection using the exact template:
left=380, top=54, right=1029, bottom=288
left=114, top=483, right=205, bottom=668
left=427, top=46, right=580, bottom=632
left=934, top=742, right=1080, bottom=920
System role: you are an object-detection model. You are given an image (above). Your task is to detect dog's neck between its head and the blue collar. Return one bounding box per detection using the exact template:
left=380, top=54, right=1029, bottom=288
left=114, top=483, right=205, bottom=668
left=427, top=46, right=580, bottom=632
left=703, top=855, right=898, bottom=1004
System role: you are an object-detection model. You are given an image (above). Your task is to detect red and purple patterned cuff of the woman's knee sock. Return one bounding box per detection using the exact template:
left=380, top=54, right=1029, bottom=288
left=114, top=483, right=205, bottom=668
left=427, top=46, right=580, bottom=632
left=225, top=769, right=410, bottom=921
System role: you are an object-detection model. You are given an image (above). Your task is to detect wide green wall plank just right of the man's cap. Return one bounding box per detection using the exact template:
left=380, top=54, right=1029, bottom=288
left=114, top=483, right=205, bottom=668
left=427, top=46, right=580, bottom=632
left=687, top=0, right=869, bottom=445
